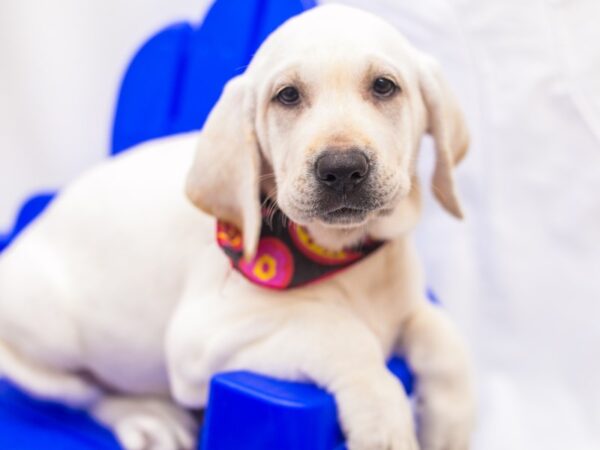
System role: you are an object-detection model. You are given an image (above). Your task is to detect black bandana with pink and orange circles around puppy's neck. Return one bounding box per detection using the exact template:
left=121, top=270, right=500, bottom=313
left=217, top=200, right=384, bottom=290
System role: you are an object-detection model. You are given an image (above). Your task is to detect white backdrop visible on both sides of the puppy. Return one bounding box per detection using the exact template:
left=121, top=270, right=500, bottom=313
left=0, top=0, right=600, bottom=450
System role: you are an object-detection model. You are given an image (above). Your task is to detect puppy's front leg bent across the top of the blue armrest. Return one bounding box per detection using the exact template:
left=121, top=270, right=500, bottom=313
left=167, top=293, right=417, bottom=450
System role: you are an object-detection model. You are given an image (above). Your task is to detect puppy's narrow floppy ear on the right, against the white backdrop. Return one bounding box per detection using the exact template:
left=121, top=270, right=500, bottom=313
left=420, top=55, right=469, bottom=219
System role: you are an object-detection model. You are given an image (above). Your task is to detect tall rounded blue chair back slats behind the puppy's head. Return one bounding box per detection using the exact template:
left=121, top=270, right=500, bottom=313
left=111, top=0, right=314, bottom=154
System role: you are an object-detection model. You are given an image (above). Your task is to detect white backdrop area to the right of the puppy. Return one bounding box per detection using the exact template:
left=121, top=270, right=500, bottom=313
left=342, top=0, right=600, bottom=450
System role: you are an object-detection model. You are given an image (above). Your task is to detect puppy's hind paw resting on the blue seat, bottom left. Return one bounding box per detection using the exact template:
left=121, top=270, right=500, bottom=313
left=92, top=397, right=198, bottom=450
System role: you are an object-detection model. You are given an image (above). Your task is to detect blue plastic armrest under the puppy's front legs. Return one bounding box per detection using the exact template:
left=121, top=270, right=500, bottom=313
left=200, top=358, right=413, bottom=450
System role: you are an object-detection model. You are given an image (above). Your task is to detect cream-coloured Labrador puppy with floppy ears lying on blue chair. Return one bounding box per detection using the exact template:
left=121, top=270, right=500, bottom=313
left=0, top=6, right=473, bottom=450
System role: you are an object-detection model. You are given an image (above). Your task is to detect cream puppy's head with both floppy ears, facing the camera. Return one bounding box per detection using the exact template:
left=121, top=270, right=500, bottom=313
left=187, top=6, right=468, bottom=256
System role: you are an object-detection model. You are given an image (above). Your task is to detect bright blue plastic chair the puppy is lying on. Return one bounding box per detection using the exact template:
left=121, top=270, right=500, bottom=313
left=0, top=0, right=412, bottom=450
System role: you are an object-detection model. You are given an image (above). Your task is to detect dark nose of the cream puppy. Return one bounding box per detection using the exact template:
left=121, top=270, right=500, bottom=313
left=315, top=149, right=369, bottom=193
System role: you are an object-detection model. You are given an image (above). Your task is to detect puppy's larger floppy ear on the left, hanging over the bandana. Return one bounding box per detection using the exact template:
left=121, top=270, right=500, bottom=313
left=186, top=75, right=261, bottom=259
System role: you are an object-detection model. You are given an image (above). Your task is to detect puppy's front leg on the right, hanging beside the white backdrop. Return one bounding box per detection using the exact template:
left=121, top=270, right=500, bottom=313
left=398, top=300, right=475, bottom=450
